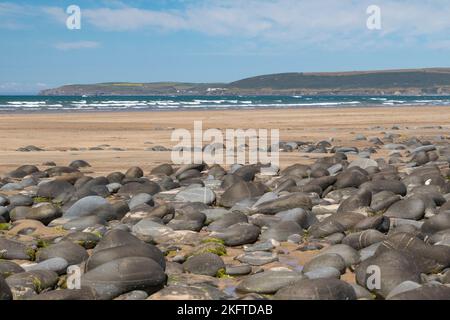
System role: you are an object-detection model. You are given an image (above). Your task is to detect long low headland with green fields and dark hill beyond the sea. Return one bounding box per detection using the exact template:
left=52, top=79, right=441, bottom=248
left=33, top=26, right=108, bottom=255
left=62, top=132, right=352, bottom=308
left=40, top=68, right=450, bottom=96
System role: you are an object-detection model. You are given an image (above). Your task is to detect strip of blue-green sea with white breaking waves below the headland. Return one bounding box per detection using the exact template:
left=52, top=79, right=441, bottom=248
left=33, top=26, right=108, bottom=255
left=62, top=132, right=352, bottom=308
left=0, top=95, right=450, bottom=113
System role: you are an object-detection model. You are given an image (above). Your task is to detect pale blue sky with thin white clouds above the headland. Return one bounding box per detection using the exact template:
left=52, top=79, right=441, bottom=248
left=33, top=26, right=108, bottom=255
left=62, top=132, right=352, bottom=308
left=0, top=0, right=450, bottom=94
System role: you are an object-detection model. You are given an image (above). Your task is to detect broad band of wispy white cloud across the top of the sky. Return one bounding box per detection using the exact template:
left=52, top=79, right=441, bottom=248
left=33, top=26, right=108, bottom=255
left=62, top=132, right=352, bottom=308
left=0, top=0, right=450, bottom=49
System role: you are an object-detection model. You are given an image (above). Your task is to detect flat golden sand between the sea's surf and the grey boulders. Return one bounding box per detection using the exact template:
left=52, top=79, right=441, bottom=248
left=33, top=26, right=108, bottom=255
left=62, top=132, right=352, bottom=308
left=0, top=106, right=450, bottom=175
